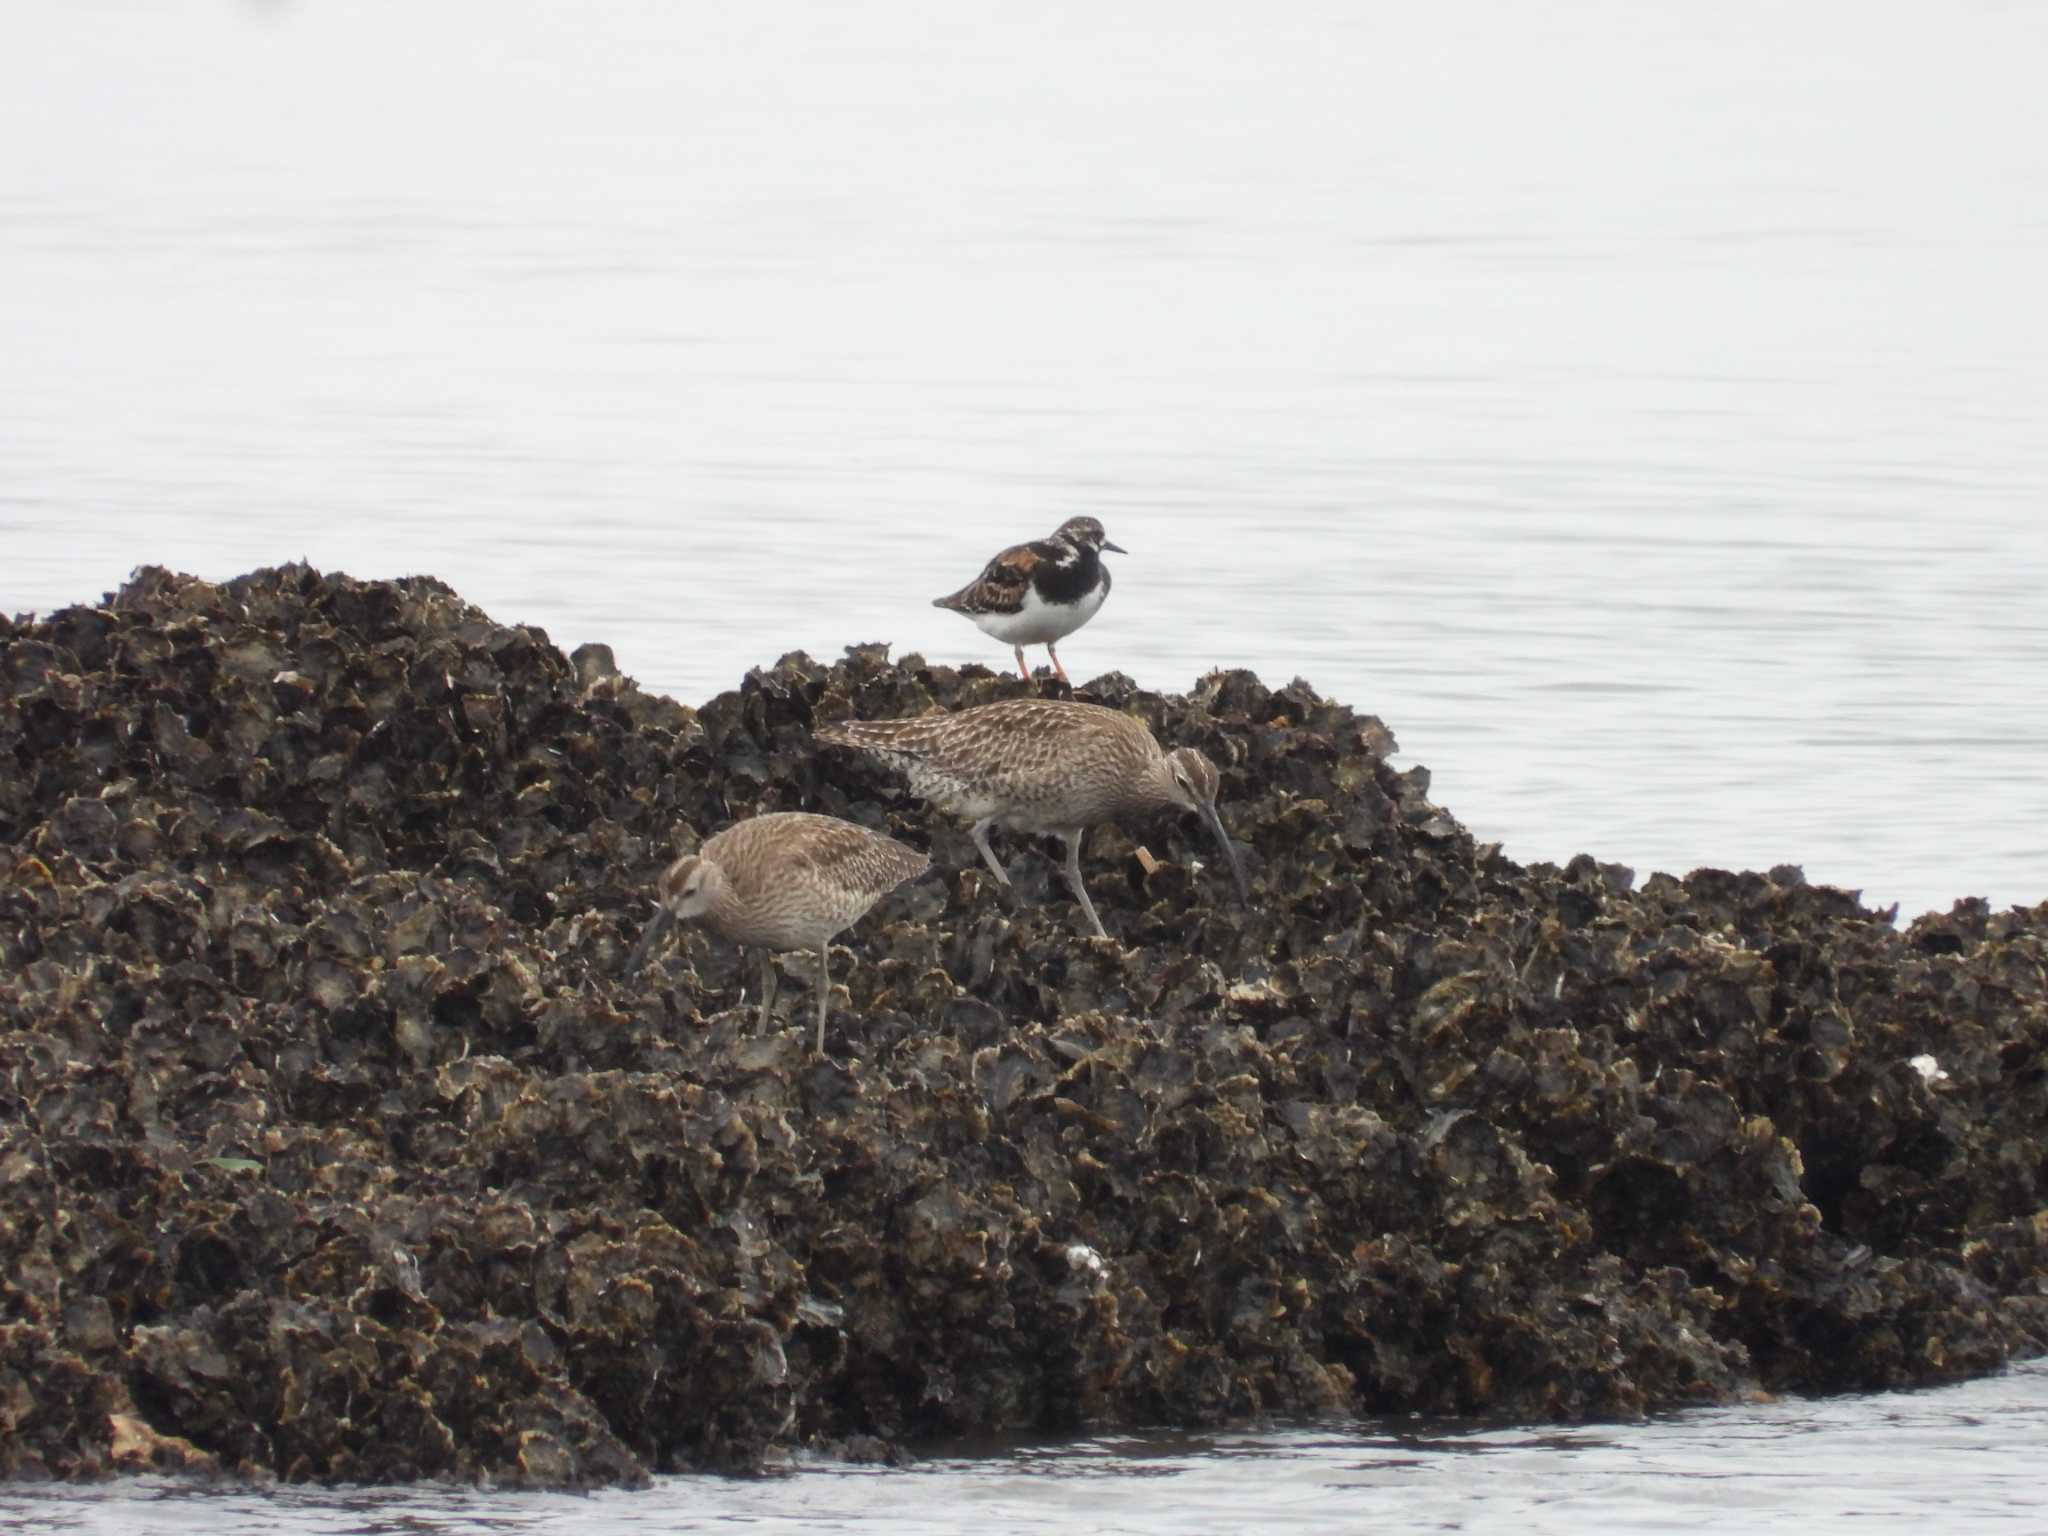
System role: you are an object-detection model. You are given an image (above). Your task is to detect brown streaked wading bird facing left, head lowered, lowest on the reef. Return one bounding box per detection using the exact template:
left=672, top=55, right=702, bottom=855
left=627, top=811, right=932, bottom=1055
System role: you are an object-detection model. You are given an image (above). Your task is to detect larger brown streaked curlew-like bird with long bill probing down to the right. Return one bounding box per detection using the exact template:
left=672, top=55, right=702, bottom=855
left=817, top=698, right=1251, bottom=938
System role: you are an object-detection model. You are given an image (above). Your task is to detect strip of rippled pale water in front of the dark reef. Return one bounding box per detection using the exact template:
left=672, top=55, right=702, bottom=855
left=0, top=1364, right=2048, bottom=1536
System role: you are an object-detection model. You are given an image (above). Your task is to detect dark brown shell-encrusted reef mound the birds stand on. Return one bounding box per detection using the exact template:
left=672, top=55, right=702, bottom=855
left=0, top=567, right=2048, bottom=1485
